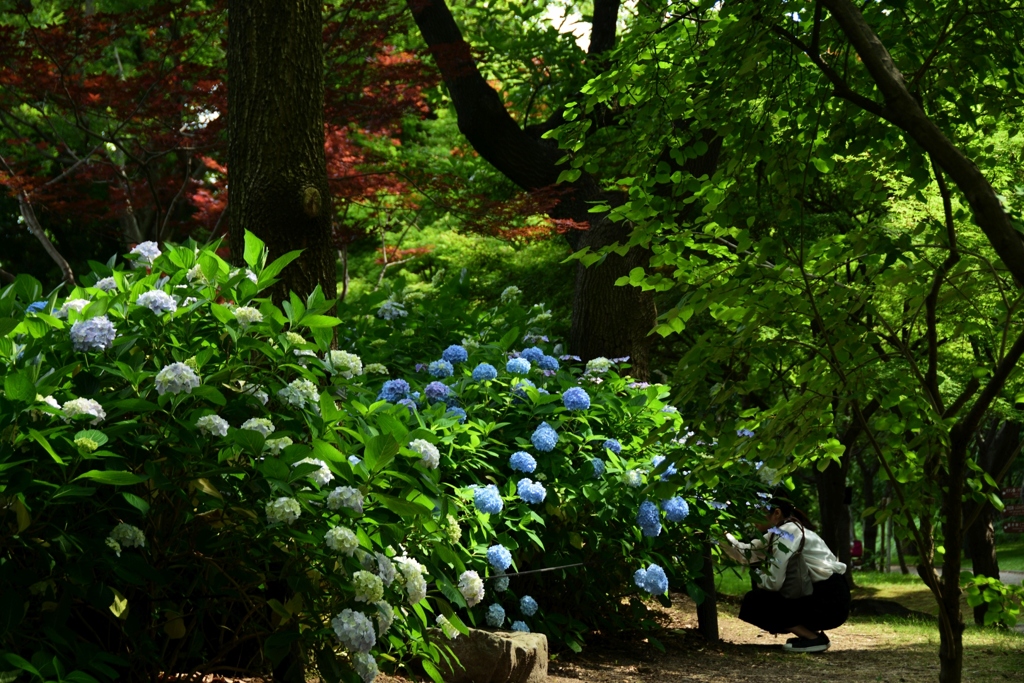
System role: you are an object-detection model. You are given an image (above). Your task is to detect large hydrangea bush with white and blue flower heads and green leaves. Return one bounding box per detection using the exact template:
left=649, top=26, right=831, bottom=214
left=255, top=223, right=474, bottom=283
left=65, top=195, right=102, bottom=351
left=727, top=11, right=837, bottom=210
left=0, top=236, right=770, bottom=681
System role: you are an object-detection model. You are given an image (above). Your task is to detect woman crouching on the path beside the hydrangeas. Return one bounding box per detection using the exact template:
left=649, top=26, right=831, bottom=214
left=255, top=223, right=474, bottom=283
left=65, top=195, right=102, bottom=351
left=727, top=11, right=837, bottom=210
left=723, top=498, right=850, bottom=652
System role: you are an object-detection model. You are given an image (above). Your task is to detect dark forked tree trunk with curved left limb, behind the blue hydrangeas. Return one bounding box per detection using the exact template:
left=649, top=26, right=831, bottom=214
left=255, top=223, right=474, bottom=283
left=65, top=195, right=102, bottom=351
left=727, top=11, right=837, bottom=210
left=407, top=0, right=663, bottom=379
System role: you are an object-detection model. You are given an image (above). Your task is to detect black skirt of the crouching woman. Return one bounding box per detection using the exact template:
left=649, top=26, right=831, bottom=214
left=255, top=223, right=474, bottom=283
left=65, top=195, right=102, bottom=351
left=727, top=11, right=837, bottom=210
left=739, top=573, right=850, bottom=633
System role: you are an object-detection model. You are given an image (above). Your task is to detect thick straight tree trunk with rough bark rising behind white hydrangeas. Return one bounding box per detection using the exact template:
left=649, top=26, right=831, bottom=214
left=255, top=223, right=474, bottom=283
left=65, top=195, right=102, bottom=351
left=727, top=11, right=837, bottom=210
left=227, top=0, right=337, bottom=298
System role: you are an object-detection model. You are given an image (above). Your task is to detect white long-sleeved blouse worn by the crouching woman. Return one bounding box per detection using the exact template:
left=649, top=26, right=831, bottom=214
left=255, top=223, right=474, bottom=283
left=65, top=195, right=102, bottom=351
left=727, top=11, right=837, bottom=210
left=721, top=522, right=846, bottom=591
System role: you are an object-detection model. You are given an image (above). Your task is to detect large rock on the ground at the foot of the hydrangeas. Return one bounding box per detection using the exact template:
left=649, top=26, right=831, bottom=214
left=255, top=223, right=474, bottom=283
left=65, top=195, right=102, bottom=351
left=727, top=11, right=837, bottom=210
left=431, top=629, right=548, bottom=683
